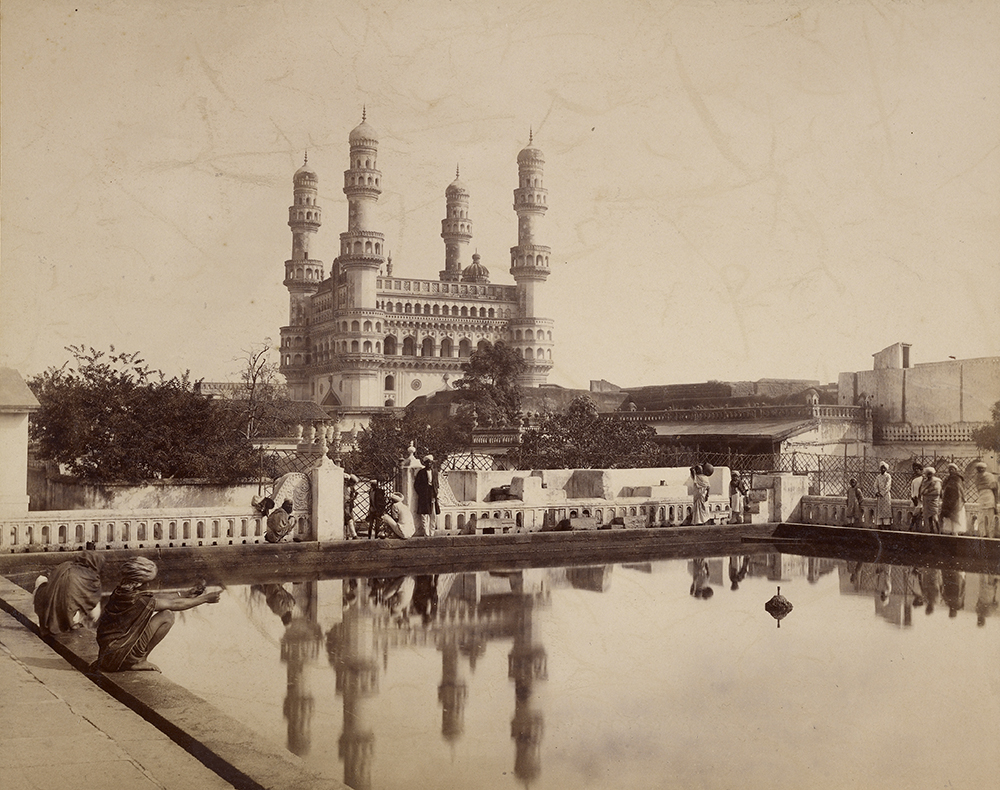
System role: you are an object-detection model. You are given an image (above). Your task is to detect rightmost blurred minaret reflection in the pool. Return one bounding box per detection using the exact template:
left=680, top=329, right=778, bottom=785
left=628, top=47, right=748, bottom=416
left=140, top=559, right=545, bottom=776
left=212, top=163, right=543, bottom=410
left=507, top=583, right=548, bottom=782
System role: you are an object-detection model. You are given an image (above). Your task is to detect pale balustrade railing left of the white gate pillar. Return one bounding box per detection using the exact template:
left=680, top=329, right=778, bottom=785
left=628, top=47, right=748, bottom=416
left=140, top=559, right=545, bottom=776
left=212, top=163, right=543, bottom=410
left=0, top=508, right=312, bottom=553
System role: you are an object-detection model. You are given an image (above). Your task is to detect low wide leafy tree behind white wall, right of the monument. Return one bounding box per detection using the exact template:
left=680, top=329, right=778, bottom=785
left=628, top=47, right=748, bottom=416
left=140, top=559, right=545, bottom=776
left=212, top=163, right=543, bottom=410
left=511, top=396, right=659, bottom=469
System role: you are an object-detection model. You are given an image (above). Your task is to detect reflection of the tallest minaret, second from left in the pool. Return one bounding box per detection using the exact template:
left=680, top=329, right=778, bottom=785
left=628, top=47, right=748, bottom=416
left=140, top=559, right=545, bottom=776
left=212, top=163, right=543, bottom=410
left=326, top=582, right=379, bottom=790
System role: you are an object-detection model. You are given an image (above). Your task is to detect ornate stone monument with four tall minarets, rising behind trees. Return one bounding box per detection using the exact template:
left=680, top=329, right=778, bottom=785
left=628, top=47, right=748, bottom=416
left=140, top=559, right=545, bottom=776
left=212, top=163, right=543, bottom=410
left=281, top=114, right=552, bottom=414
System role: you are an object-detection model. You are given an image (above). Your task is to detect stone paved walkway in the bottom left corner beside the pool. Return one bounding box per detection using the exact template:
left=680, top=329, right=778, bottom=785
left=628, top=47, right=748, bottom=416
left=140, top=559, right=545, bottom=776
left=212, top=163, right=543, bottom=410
left=0, top=611, right=232, bottom=790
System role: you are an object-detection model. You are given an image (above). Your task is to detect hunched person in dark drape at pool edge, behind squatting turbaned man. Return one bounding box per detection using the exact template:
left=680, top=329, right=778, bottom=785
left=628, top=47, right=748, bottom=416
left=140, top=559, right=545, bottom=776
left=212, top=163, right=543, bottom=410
left=34, top=551, right=104, bottom=634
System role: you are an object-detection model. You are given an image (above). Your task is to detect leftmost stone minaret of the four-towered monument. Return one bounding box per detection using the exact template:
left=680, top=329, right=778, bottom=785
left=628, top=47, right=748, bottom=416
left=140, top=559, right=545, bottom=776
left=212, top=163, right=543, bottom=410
left=281, top=155, right=324, bottom=400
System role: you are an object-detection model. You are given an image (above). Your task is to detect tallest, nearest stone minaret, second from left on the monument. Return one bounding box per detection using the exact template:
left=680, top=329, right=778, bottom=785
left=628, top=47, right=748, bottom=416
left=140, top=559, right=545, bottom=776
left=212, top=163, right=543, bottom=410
left=336, top=114, right=385, bottom=407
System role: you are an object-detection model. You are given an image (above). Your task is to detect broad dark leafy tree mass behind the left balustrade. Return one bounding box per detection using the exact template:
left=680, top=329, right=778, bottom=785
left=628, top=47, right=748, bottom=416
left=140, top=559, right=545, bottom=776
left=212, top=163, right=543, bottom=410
left=28, top=346, right=258, bottom=483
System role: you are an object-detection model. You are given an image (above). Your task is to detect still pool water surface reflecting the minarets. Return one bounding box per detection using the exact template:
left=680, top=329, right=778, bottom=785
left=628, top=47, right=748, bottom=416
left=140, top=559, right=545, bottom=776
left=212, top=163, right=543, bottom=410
left=153, top=554, right=1000, bottom=790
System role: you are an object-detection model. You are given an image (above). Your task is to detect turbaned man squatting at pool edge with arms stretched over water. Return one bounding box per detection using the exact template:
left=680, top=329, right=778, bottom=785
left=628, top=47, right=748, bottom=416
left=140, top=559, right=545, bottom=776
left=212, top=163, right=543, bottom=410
left=94, top=557, right=219, bottom=672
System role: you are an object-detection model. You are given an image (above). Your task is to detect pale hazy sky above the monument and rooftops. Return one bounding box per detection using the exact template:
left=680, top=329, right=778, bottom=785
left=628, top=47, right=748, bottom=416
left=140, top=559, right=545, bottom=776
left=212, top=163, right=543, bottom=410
left=0, top=0, right=1000, bottom=387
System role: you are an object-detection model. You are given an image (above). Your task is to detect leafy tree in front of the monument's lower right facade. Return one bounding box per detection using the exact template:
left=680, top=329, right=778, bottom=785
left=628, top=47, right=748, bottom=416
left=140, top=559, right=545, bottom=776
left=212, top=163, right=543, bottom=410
left=455, top=341, right=525, bottom=425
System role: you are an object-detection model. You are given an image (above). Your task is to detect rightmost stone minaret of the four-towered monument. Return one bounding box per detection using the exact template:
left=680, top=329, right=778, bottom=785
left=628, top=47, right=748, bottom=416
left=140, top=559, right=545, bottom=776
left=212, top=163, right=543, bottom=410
left=510, top=134, right=552, bottom=387
